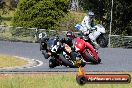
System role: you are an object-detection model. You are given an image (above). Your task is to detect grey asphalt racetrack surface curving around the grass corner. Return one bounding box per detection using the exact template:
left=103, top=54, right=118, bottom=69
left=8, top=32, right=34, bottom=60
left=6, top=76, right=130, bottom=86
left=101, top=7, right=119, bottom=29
left=0, top=41, right=132, bottom=72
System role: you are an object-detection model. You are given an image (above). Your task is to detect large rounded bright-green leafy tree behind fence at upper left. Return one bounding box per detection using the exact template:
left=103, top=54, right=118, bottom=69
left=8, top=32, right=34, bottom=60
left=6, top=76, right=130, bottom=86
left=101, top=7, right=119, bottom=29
left=13, top=0, right=69, bottom=29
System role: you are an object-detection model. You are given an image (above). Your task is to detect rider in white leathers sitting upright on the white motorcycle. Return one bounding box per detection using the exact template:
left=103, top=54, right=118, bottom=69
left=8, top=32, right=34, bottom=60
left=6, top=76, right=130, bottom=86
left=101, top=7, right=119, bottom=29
left=75, top=11, right=100, bottom=49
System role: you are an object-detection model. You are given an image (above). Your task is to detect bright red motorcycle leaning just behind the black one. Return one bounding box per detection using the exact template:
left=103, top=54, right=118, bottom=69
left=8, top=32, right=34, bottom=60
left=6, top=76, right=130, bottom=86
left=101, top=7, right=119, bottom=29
left=74, top=37, right=101, bottom=64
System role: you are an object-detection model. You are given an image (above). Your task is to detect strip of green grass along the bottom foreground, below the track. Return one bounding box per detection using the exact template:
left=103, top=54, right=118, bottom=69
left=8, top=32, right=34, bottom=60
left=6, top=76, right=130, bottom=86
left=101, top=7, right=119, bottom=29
left=0, top=73, right=132, bottom=88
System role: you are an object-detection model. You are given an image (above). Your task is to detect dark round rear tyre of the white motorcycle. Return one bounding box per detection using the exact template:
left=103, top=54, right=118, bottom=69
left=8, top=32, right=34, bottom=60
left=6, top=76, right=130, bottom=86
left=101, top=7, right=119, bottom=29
left=97, top=35, right=108, bottom=48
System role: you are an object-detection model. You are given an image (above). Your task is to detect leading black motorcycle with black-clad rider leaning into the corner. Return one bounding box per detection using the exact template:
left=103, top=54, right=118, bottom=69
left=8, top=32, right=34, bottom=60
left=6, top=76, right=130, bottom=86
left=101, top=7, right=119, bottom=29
left=40, top=33, right=86, bottom=68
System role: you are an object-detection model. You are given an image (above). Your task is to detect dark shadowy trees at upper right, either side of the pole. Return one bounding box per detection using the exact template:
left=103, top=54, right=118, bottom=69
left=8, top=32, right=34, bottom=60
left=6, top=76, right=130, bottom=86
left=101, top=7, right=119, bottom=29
left=79, top=0, right=132, bottom=35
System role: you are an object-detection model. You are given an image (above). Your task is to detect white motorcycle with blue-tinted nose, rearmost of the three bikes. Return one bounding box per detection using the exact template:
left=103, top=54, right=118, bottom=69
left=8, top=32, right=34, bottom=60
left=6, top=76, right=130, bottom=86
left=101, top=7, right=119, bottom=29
left=75, top=24, right=108, bottom=48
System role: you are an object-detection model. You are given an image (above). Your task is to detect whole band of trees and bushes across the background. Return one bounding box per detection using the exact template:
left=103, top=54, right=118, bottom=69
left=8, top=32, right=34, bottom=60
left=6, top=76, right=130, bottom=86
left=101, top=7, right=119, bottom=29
left=0, top=0, right=132, bottom=35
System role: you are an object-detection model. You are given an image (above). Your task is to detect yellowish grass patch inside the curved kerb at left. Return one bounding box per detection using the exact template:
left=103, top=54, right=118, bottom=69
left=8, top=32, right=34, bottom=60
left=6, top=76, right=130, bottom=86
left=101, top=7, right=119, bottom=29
left=0, top=54, right=28, bottom=68
